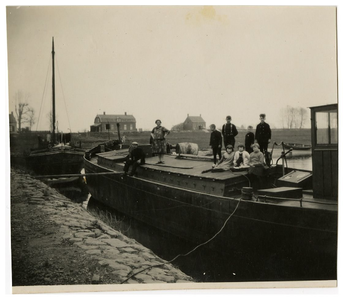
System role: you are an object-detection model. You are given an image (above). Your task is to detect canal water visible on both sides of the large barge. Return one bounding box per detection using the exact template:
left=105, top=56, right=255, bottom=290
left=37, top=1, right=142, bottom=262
left=85, top=153, right=331, bottom=282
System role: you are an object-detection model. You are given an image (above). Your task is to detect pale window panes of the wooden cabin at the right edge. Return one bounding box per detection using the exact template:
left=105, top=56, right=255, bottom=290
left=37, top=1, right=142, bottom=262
left=315, top=111, right=338, bottom=145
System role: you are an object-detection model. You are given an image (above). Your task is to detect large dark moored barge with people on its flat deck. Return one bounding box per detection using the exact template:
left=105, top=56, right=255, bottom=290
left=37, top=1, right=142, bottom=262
left=84, top=106, right=338, bottom=280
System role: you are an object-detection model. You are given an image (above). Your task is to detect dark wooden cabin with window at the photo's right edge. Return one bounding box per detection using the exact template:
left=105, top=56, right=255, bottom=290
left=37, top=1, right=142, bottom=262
left=310, top=104, right=338, bottom=199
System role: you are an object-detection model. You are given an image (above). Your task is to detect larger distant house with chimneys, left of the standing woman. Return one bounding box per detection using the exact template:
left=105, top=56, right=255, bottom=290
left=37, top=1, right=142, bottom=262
left=90, top=112, right=136, bottom=132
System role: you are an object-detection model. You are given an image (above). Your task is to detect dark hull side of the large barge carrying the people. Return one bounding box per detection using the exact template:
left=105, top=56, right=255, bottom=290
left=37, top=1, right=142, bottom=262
left=84, top=159, right=337, bottom=279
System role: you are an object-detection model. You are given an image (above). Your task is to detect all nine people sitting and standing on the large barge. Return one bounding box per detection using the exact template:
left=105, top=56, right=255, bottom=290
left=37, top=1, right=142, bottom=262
left=124, top=114, right=271, bottom=175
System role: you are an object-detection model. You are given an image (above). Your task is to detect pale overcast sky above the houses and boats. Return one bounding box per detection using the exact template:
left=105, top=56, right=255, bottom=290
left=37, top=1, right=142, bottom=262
left=7, top=6, right=337, bottom=132
